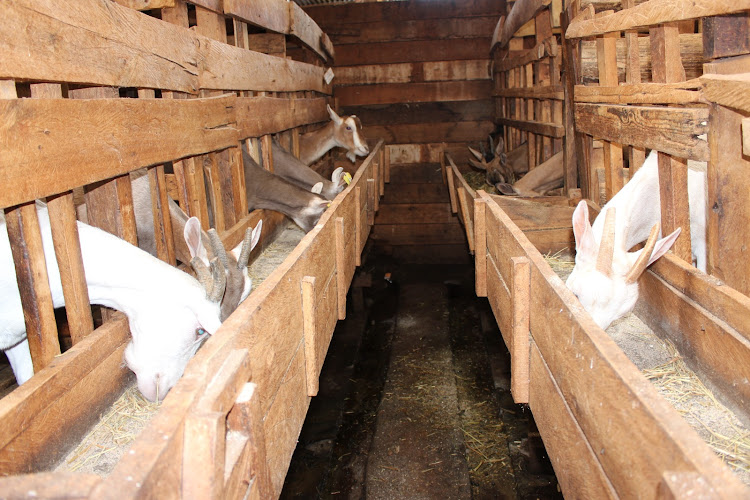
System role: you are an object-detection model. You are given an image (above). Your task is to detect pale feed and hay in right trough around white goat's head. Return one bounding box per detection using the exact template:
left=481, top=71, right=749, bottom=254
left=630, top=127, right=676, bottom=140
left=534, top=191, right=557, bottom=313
left=544, top=252, right=750, bottom=484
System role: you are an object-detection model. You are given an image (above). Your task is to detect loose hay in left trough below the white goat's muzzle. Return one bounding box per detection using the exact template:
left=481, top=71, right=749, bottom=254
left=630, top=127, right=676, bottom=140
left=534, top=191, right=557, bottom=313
left=57, top=384, right=161, bottom=476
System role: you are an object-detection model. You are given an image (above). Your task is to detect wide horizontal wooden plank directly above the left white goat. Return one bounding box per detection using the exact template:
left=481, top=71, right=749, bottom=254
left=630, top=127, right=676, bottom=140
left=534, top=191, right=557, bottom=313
left=0, top=97, right=238, bottom=207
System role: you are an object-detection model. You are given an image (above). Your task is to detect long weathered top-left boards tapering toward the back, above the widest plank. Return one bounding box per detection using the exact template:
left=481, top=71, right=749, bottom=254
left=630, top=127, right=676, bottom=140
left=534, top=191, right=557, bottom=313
left=0, top=0, right=330, bottom=93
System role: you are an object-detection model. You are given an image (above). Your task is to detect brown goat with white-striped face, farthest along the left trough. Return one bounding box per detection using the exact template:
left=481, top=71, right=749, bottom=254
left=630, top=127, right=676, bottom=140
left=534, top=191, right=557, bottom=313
left=299, top=106, right=370, bottom=165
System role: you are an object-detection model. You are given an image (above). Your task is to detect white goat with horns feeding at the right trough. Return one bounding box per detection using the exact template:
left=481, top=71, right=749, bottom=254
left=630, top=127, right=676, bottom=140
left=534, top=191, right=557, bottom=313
left=566, top=152, right=706, bottom=329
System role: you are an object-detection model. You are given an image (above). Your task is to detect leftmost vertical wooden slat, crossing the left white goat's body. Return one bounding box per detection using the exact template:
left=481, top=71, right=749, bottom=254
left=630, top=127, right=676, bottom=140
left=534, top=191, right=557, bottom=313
left=5, top=201, right=60, bottom=372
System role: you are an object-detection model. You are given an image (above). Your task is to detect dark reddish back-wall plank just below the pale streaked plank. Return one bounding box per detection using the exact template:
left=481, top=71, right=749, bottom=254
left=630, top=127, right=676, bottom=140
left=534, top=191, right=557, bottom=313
left=336, top=80, right=492, bottom=106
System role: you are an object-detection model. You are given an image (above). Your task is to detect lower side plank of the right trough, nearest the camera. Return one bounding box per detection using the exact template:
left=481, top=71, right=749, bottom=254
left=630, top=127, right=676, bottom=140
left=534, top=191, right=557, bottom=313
left=529, top=342, right=618, bottom=498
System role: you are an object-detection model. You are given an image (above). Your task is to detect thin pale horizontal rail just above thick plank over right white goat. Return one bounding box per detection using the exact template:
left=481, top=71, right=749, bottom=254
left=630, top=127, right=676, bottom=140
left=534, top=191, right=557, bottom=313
left=575, top=80, right=708, bottom=104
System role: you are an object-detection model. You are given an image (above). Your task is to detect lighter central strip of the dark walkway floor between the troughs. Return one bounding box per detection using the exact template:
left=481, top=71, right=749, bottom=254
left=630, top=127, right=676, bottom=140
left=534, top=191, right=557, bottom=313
left=366, top=284, right=471, bottom=500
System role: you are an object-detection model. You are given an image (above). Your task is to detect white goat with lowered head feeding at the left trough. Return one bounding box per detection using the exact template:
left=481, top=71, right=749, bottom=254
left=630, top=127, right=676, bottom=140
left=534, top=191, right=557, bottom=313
left=0, top=202, right=225, bottom=401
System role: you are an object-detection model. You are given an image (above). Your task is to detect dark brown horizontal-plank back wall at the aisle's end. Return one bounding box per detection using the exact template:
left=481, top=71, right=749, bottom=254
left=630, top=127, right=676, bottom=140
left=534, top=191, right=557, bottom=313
left=305, top=0, right=505, bottom=262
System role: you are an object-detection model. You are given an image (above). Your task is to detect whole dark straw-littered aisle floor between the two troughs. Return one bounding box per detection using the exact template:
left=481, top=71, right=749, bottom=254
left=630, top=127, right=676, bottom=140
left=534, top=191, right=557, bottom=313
left=281, top=248, right=561, bottom=499
